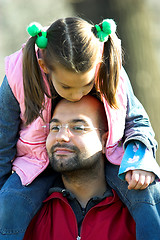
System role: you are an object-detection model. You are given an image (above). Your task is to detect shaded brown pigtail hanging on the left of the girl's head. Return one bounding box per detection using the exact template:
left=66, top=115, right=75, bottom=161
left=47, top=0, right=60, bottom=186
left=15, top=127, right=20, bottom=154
left=23, top=37, right=45, bottom=125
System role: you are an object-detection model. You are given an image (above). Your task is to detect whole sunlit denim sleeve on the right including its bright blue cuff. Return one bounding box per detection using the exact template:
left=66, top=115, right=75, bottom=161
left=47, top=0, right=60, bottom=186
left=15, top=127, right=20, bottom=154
left=118, top=69, right=160, bottom=180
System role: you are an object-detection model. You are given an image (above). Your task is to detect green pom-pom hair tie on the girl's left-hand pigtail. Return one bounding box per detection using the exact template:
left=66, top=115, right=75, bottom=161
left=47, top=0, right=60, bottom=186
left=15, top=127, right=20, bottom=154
left=27, top=22, right=48, bottom=49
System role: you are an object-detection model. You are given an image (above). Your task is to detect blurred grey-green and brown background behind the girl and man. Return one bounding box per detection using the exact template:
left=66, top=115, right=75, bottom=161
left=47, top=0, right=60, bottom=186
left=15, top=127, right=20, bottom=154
left=0, top=0, right=160, bottom=164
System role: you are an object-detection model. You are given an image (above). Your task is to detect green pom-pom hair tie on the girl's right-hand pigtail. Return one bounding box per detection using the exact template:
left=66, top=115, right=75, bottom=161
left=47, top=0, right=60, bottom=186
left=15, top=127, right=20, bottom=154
left=95, top=19, right=117, bottom=42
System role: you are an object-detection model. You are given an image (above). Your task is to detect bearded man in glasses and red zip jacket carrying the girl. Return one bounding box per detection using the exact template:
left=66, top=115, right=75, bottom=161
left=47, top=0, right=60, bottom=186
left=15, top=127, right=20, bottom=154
left=24, top=96, right=136, bottom=240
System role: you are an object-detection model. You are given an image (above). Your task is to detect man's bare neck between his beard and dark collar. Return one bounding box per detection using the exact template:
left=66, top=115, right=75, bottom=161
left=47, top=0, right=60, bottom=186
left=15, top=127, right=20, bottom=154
left=62, top=161, right=107, bottom=207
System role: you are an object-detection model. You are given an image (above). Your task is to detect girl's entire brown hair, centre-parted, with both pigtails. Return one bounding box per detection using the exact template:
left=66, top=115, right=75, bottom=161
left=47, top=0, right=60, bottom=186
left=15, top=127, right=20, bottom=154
left=23, top=17, right=121, bottom=125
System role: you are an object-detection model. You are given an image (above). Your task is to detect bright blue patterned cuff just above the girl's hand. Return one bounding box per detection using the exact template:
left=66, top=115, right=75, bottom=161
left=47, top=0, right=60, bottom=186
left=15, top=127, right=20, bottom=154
left=118, top=141, right=160, bottom=180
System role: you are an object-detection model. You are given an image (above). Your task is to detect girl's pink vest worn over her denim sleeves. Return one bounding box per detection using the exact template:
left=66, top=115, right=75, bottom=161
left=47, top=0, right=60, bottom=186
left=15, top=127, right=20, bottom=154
left=5, top=49, right=127, bottom=185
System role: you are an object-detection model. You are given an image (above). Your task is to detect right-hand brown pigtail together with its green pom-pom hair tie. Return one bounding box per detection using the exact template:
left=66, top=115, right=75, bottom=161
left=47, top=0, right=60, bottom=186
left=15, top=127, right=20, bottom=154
left=92, top=19, right=121, bottom=108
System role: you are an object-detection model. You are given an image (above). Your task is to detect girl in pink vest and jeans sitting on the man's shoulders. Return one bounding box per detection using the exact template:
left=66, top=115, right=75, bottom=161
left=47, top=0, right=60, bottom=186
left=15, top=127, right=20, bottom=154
left=0, top=17, right=160, bottom=240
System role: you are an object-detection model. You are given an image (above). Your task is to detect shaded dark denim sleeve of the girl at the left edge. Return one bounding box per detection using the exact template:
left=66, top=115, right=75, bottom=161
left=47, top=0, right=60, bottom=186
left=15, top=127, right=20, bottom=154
left=0, top=76, right=20, bottom=188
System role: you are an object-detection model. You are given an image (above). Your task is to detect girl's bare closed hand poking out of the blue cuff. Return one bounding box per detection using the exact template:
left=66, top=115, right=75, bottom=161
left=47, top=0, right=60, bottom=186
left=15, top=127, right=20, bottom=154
left=125, top=170, right=155, bottom=190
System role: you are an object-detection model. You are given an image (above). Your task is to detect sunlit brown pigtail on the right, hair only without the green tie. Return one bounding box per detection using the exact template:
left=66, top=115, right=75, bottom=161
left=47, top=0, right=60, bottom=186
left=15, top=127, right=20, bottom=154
left=96, top=36, right=121, bottom=108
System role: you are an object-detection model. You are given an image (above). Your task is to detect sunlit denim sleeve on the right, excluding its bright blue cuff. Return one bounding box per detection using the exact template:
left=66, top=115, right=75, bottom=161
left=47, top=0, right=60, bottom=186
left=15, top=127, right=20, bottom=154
left=123, top=67, right=157, bottom=158
